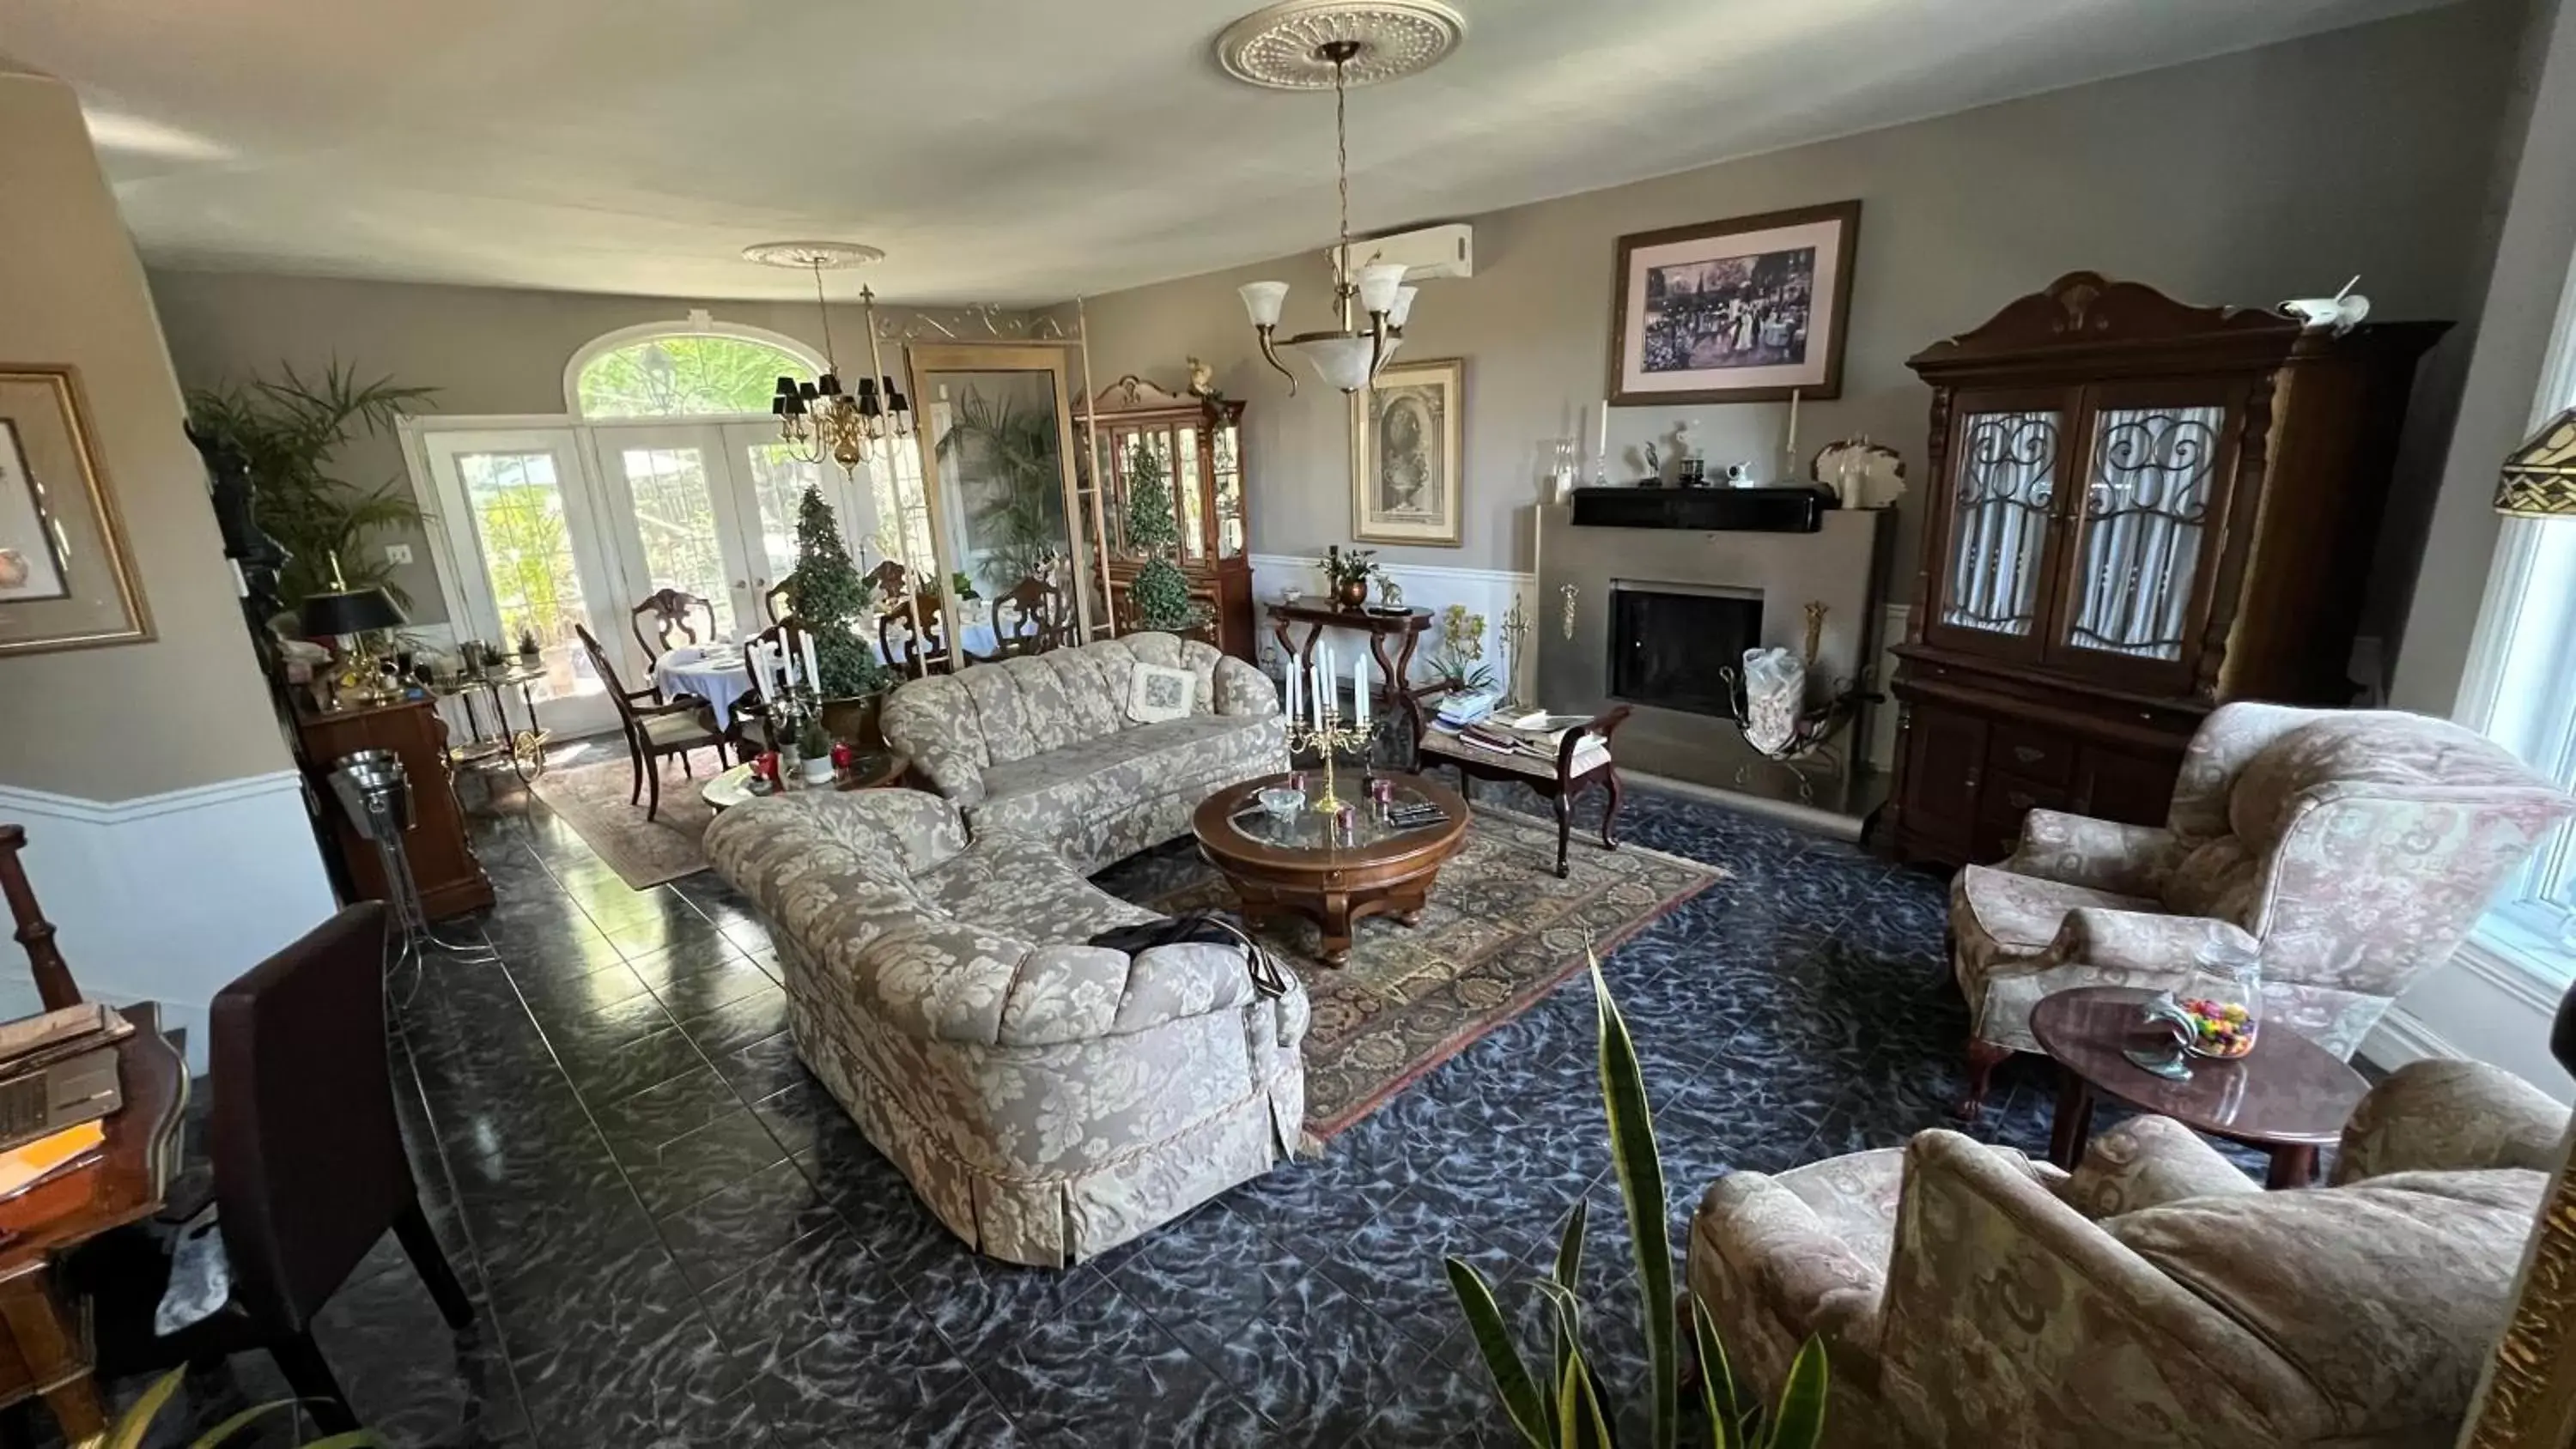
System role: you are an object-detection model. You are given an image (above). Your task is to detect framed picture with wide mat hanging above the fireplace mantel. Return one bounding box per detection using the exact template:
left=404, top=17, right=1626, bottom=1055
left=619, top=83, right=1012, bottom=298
left=1610, top=201, right=1860, bottom=407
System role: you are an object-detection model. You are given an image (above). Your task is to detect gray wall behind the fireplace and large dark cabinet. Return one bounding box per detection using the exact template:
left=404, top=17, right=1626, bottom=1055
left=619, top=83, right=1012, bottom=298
left=1087, top=0, right=2524, bottom=651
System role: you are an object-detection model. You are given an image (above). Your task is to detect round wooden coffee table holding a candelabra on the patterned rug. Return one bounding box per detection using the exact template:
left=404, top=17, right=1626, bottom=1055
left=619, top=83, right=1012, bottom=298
left=1190, top=772, right=1466, bottom=965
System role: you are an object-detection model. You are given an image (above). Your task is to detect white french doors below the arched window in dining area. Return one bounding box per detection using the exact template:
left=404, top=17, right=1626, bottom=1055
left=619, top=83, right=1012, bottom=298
left=422, top=422, right=876, bottom=733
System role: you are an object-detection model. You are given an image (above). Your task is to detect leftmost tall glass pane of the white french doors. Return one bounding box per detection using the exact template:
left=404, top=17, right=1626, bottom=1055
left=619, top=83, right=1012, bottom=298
left=456, top=453, right=603, bottom=700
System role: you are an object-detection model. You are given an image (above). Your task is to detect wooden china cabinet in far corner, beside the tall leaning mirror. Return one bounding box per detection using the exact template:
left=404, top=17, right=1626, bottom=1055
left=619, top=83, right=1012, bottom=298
left=1074, top=373, right=1257, bottom=662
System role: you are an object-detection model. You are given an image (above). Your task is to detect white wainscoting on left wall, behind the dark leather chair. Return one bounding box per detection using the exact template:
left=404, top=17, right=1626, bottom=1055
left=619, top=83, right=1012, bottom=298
left=0, top=769, right=340, bottom=1070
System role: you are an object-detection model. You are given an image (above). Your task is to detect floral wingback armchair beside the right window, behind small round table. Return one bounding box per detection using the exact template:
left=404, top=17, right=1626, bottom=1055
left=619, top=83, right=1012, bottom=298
left=1950, top=706, right=2576, bottom=1119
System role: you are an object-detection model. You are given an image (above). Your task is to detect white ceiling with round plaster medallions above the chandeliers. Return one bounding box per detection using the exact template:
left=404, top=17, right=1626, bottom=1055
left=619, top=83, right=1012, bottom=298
left=0, top=0, right=2442, bottom=304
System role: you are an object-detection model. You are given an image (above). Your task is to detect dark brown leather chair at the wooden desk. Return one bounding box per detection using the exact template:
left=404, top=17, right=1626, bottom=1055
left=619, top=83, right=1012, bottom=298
left=75, top=900, right=474, bottom=1434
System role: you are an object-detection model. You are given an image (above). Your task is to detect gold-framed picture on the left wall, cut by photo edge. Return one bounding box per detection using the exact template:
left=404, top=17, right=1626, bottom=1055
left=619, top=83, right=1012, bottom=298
left=0, top=363, right=152, bottom=654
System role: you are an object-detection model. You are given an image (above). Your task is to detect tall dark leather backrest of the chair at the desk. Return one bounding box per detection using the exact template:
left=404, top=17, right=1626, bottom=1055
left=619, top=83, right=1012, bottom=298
left=206, top=900, right=420, bottom=1333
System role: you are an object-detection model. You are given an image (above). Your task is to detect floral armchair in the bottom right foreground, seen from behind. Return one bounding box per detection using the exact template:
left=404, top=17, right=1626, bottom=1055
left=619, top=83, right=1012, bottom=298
left=1690, top=1063, right=2568, bottom=1449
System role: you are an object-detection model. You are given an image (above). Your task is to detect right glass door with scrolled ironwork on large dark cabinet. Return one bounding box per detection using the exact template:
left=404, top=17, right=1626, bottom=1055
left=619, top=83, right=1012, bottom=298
left=2048, top=384, right=2239, bottom=685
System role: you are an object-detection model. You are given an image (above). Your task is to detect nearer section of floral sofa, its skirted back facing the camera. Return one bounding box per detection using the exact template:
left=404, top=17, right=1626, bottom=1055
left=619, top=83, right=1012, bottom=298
left=706, top=790, right=1306, bottom=1266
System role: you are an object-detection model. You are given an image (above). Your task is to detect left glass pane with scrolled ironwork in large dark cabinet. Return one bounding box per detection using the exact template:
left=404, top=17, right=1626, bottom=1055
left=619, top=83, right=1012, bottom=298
left=1940, top=412, right=2058, bottom=636
